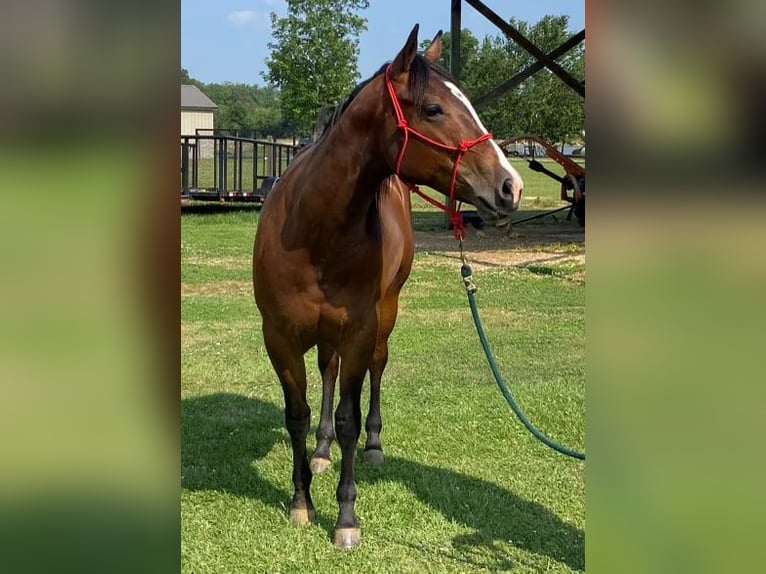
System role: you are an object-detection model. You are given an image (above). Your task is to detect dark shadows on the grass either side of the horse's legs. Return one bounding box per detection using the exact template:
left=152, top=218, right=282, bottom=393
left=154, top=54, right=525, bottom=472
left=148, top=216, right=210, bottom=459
left=181, top=394, right=585, bottom=570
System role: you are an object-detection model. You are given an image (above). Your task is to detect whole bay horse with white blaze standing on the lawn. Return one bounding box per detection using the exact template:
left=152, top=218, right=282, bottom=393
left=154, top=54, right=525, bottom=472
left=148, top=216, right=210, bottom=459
left=253, top=25, right=523, bottom=548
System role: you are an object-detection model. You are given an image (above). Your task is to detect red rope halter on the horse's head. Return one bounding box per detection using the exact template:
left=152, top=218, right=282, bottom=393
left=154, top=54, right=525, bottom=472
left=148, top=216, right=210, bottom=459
left=386, top=65, right=493, bottom=240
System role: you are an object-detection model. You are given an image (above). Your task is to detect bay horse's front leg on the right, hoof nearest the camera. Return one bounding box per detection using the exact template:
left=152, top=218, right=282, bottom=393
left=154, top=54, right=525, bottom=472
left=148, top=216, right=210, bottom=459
left=334, top=330, right=376, bottom=549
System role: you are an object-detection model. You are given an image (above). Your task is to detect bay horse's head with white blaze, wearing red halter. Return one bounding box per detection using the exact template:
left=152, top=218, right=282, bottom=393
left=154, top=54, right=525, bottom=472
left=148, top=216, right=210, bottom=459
left=384, top=26, right=524, bottom=223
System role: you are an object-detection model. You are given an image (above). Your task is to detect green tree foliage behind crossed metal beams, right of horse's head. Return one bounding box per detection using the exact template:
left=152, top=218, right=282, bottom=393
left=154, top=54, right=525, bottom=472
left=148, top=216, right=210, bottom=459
left=432, top=16, right=585, bottom=143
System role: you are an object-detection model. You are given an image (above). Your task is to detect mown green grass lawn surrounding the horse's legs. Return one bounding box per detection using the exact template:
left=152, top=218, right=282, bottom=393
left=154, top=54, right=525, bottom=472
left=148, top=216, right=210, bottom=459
left=181, top=206, right=585, bottom=573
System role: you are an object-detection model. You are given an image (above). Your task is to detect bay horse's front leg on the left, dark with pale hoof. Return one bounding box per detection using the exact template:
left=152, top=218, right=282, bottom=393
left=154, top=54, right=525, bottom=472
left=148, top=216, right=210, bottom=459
left=263, top=322, right=315, bottom=526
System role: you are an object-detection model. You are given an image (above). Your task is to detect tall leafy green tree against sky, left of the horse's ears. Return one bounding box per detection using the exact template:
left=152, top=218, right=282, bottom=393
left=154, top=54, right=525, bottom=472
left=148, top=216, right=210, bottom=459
left=263, top=0, right=369, bottom=134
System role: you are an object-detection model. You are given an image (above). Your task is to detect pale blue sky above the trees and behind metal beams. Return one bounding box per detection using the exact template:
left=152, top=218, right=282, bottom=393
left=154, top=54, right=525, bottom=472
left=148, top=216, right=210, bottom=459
left=181, top=0, right=585, bottom=85
